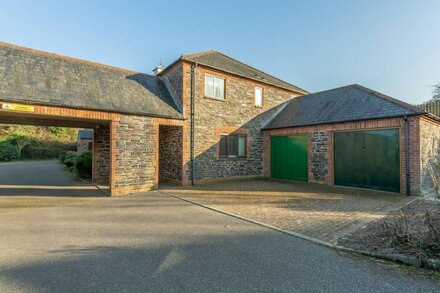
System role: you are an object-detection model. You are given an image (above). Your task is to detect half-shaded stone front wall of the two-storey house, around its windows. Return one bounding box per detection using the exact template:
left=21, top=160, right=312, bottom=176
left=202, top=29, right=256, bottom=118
left=174, top=63, right=299, bottom=181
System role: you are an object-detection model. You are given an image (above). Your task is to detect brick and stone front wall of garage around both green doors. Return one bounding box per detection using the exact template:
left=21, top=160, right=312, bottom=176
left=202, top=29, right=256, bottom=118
left=264, top=117, right=421, bottom=195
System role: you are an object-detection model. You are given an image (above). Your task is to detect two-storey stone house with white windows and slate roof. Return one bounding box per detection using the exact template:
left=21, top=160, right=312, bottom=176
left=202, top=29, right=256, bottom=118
left=158, top=51, right=307, bottom=184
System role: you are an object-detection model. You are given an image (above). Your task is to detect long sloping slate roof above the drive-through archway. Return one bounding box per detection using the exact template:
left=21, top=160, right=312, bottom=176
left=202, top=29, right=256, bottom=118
left=0, top=43, right=182, bottom=118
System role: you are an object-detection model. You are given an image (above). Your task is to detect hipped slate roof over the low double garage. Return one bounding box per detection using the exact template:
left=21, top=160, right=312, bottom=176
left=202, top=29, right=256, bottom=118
left=264, top=84, right=426, bottom=129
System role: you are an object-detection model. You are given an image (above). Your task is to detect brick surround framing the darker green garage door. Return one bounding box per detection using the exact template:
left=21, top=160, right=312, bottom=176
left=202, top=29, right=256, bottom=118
left=330, top=127, right=404, bottom=193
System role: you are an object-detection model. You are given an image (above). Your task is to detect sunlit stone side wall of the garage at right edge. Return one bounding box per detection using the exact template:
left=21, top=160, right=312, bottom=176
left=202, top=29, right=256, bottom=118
left=420, top=118, right=440, bottom=197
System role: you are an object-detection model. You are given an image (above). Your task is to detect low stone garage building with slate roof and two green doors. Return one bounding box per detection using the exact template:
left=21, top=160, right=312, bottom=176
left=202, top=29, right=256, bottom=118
left=263, top=85, right=440, bottom=194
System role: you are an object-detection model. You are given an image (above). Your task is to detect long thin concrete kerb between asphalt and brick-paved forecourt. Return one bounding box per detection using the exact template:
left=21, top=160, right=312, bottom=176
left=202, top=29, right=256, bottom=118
left=158, top=190, right=440, bottom=271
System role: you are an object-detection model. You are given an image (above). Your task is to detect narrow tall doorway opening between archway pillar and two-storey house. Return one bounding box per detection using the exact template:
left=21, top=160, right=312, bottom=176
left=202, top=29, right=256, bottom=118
left=159, top=125, right=183, bottom=184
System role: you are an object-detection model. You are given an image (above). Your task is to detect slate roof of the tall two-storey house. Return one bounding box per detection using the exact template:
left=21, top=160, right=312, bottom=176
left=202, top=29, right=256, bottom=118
left=174, top=50, right=309, bottom=94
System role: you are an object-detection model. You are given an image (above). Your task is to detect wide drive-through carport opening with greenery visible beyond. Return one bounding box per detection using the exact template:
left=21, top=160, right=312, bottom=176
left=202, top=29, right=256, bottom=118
left=0, top=111, right=111, bottom=197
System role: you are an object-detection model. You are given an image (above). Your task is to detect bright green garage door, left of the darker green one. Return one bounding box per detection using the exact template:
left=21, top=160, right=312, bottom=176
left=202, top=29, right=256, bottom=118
left=270, top=135, right=308, bottom=181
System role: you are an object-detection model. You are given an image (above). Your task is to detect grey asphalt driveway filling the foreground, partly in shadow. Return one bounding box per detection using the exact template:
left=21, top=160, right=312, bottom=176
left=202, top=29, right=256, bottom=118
left=0, top=192, right=440, bottom=293
